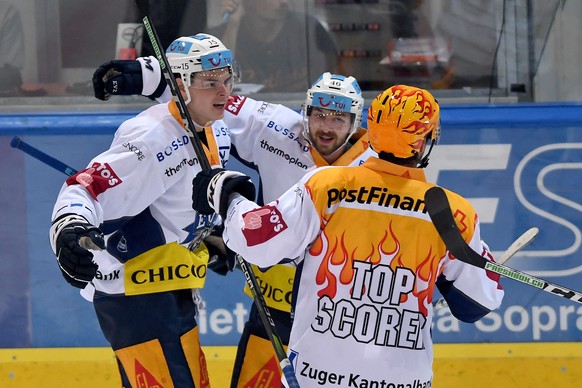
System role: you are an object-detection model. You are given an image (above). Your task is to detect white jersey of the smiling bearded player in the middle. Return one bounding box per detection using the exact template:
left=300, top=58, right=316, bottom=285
left=224, top=96, right=376, bottom=311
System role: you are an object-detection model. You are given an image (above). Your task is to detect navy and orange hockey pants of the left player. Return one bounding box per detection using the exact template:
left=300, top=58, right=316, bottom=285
left=93, top=290, right=210, bottom=388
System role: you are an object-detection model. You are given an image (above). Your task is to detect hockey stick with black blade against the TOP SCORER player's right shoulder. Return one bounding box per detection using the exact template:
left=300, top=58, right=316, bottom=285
left=424, top=186, right=582, bottom=303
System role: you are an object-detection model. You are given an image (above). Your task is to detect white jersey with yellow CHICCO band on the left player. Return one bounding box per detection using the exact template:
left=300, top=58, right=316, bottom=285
left=52, top=102, right=230, bottom=299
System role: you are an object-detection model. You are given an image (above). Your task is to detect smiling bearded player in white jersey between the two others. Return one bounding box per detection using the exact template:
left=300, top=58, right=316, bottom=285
left=93, top=58, right=376, bottom=388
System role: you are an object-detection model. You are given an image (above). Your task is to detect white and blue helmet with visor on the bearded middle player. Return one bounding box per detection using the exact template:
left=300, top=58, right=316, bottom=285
left=303, top=72, right=364, bottom=142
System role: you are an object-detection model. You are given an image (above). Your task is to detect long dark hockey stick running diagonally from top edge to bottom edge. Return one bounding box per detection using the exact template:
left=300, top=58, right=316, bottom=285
left=135, top=0, right=299, bottom=388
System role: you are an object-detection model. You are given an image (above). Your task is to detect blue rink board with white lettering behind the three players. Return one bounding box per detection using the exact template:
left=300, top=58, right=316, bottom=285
left=0, top=104, right=582, bottom=386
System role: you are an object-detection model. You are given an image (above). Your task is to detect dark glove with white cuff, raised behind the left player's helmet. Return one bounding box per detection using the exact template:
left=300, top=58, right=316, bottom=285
left=93, top=56, right=167, bottom=101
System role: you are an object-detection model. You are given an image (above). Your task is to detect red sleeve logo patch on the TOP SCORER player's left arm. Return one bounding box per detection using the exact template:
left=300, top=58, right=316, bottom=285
left=242, top=205, right=287, bottom=247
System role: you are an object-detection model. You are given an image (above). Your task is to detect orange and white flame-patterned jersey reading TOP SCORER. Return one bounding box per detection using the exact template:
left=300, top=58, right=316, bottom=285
left=224, top=157, right=503, bottom=387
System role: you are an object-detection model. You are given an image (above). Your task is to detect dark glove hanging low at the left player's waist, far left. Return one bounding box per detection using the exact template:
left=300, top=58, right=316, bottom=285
left=50, top=214, right=105, bottom=288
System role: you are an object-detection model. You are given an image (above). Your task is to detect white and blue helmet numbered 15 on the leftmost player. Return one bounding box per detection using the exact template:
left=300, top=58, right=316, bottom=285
left=166, top=33, right=238, bottom=103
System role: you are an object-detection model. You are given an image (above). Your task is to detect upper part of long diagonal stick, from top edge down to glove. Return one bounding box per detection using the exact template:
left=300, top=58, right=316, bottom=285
left=135, top=0, right=211, bottom=170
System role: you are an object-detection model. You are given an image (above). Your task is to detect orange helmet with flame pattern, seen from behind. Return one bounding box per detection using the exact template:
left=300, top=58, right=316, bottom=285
left=368, top=85, right=441, bottom=168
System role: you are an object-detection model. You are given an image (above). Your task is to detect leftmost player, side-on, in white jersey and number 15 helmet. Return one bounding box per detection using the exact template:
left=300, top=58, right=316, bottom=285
left=50, top=34, right=254, bottom=388
